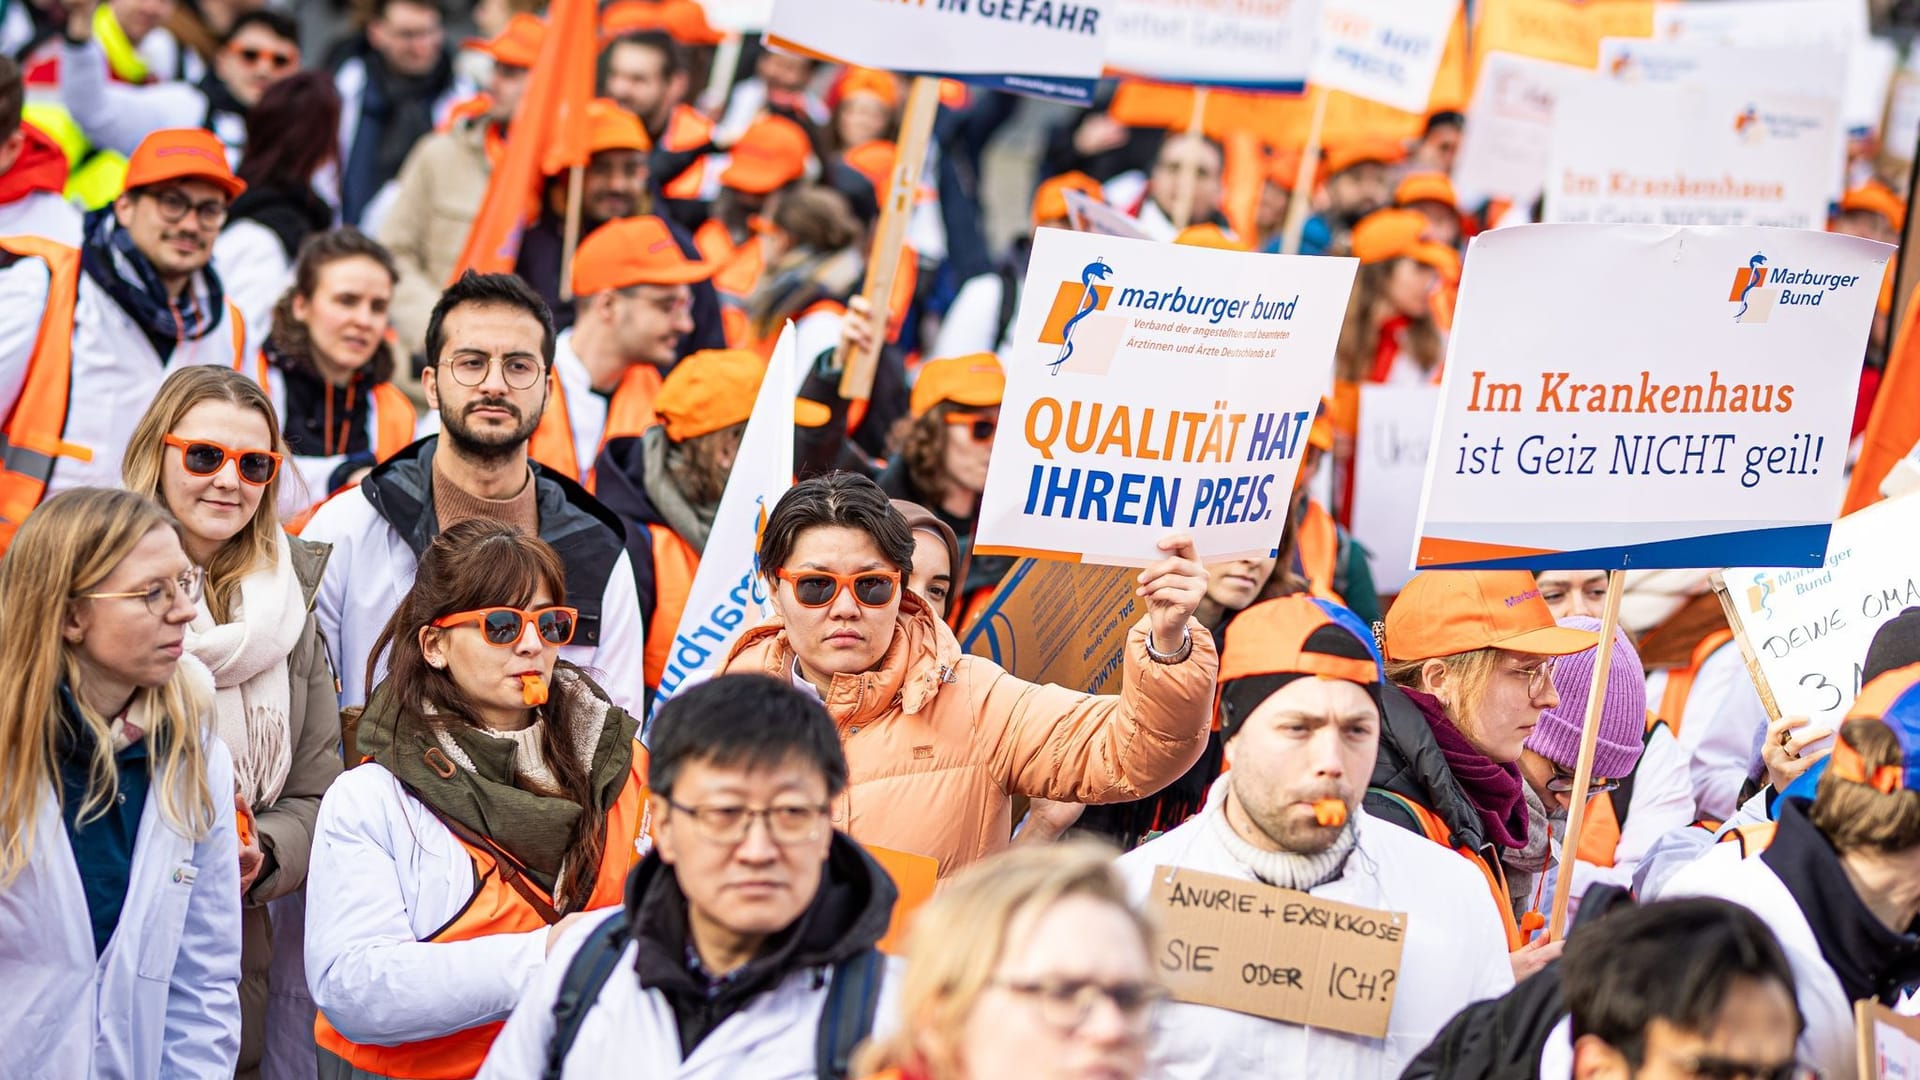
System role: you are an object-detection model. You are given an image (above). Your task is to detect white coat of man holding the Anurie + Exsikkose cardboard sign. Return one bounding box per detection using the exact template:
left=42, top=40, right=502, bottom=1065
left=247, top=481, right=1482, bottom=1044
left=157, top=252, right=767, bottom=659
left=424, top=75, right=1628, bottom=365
left=1117, top=799, right=1513, bottom=1080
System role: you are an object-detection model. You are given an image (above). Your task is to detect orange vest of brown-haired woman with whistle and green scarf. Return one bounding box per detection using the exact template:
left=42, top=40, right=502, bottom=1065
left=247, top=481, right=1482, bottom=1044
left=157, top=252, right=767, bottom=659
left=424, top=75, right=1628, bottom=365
left=313, top=746, right=649, bottom=1080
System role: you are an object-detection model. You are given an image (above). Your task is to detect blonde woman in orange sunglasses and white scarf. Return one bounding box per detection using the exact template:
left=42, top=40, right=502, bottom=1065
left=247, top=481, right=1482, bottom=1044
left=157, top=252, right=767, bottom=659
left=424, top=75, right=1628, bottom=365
left=121, top=367, right=340, bottom=1076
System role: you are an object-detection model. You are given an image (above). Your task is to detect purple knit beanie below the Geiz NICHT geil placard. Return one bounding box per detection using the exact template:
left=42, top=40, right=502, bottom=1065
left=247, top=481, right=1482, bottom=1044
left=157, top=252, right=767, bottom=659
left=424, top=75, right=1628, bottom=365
left=1526, top=615, right=1647, bottom=780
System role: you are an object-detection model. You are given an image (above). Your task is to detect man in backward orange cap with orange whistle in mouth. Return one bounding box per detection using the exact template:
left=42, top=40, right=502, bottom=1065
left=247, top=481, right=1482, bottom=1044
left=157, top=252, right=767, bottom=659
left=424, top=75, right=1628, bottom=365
left=1119, top=596, right=1513, bottom=1080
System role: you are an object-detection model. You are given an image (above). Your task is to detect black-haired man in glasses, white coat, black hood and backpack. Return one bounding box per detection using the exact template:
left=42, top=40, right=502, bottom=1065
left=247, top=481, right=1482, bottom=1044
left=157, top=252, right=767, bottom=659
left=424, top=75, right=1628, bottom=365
left=480, top=675, right=899, bottom=1080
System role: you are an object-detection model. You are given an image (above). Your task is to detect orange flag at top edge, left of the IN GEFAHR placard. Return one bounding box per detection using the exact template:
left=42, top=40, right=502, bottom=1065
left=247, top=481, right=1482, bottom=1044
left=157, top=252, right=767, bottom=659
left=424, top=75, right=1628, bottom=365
left=449, top=0, right=597, bottom=281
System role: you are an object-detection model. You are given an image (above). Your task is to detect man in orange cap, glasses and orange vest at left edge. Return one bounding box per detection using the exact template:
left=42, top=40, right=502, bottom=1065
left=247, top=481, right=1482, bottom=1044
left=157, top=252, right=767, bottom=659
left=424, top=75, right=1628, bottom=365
left=0, top=129, right=246, bottom=546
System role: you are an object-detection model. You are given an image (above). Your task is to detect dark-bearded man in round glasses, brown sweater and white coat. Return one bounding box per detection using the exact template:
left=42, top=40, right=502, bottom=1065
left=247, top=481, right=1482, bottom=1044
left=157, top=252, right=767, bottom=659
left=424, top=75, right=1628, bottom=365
left=301, top=273, right=645, bottom=709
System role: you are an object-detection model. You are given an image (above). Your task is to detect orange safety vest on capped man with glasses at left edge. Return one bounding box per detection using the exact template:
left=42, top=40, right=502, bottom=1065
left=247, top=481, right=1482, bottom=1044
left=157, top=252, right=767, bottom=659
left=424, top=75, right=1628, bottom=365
left=0, top=236, right=247, bottom=552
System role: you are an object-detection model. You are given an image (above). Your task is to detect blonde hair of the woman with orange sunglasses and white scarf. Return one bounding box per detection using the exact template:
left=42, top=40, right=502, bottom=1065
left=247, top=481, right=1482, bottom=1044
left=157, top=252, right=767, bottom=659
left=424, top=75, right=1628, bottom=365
left=121, top=363, right=288, bottom=623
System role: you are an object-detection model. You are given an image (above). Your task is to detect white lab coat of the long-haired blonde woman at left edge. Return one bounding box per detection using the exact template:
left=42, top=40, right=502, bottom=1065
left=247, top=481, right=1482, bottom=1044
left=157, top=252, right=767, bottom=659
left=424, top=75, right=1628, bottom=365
left=0, top=726, right=240, bottom=1080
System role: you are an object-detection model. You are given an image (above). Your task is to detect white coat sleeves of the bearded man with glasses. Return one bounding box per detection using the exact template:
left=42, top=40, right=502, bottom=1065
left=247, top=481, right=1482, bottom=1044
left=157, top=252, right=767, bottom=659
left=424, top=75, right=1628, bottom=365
left=301, top=476, right=647, bottom=711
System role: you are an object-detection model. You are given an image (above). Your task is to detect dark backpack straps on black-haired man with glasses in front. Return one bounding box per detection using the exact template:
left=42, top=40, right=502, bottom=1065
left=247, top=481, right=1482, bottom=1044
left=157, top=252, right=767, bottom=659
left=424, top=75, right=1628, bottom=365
left=541, top=917, right=885, bottom=1080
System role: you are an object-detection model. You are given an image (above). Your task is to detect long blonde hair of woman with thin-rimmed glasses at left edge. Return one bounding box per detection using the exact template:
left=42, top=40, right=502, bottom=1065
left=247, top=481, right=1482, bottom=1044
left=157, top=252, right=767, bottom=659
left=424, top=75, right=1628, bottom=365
left=0, top=488, right=213, bottom=886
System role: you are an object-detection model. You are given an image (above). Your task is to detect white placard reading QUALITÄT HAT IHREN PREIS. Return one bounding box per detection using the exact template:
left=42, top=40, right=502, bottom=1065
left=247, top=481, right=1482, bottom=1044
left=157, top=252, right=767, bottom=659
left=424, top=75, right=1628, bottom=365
left=973, top=229, right=1356, bottom=567
